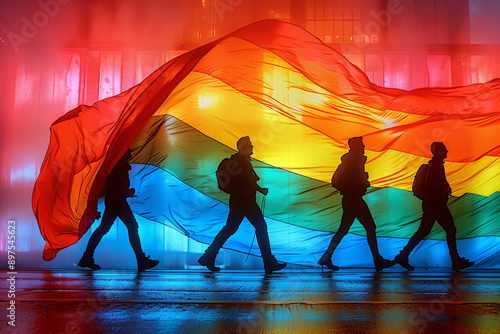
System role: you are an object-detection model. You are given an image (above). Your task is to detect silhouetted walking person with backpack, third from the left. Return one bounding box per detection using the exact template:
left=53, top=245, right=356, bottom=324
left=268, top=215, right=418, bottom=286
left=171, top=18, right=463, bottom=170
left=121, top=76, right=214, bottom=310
left=318, top=137, right=394, bottom=271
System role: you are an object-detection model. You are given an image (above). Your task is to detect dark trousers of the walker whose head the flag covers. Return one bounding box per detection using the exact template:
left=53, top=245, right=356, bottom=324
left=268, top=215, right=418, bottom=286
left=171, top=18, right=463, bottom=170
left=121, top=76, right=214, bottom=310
left=85, top=200, right=144, bottom=260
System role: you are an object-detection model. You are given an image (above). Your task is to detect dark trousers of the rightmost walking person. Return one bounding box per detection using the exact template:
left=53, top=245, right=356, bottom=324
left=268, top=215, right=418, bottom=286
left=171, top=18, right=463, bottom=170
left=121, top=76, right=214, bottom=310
left=401, top=200, right=459, bottom=261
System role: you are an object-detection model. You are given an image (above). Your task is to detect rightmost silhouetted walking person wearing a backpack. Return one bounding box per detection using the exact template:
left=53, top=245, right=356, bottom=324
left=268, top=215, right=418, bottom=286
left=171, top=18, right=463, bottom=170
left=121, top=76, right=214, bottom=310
left=394, top=142, right=474, bottom=270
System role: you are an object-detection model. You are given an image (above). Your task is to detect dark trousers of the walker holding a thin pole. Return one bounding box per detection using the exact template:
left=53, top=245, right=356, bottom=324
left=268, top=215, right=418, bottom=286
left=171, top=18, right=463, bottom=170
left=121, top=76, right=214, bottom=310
left=205, top=197, right=274, bottom=264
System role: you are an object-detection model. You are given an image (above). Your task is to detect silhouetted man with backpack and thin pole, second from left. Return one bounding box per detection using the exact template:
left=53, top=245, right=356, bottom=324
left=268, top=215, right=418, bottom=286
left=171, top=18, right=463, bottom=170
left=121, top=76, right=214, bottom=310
left=198, top=136, right=286, bottom=274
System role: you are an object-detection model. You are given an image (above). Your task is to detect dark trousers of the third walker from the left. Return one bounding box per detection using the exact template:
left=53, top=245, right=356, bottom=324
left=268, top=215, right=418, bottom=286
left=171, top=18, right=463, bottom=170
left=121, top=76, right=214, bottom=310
left=326, top=196, right=381, bottom=261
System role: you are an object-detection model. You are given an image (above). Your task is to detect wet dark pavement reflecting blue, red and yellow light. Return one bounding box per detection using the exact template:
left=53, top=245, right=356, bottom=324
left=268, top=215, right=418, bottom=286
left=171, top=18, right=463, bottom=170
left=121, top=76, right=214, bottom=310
left=0, top=269, right=500, bottom=333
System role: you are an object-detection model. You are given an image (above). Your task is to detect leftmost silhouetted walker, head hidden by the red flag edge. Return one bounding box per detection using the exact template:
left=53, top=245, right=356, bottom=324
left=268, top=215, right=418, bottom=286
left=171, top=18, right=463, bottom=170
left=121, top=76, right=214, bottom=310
left=78, top=149, right=159, bottom=271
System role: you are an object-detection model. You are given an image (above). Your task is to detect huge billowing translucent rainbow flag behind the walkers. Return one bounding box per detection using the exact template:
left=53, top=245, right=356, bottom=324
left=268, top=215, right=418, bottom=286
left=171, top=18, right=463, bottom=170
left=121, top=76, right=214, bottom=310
left=33, top=21, right=500, bottom=268
